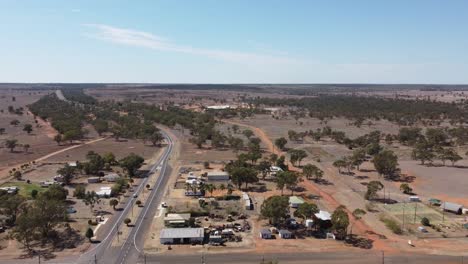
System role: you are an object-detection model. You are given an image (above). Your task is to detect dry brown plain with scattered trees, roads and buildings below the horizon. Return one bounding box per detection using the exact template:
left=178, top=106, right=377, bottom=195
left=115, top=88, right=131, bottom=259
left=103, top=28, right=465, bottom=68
left=0, top=84, right=468, bottom=261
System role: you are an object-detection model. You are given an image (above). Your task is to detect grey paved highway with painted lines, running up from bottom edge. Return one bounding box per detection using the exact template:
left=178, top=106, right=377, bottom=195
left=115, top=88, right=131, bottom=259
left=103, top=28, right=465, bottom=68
left=75, top=133, right=173, bottom=264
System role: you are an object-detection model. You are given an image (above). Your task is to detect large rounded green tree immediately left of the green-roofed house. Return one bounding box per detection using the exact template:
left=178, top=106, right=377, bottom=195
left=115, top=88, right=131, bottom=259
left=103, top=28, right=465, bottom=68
left=260, top=196, right=289, bottom=225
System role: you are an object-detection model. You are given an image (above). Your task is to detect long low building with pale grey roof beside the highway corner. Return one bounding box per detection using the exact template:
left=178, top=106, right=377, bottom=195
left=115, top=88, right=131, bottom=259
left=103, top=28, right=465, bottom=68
left=159, top=228, right=205, bottom=245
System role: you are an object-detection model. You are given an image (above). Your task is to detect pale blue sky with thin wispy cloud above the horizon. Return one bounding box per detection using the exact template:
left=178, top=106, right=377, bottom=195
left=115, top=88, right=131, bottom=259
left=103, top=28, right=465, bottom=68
left=0, top=0, right=468, bottom=84
